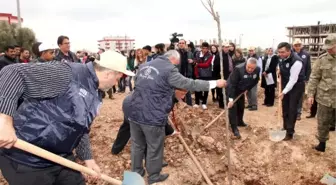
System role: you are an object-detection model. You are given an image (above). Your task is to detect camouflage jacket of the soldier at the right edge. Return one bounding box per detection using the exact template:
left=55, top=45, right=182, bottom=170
left=307, top=53, right=336, bottom=108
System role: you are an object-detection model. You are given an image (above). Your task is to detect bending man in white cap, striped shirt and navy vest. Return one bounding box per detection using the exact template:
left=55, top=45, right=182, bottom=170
left=0, top=51, right=134, bottom=185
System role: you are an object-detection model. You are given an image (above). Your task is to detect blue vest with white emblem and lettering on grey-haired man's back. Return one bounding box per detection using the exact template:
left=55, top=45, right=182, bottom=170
left=129, top=56, right=175, bottom=126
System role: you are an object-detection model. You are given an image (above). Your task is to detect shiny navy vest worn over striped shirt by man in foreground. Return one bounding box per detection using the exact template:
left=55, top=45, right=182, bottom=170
left=3, top=63, right=101, bottom=168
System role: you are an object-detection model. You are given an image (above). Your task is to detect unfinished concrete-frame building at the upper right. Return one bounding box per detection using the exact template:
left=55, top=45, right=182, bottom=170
left=287, top=22, right=336, bottom=58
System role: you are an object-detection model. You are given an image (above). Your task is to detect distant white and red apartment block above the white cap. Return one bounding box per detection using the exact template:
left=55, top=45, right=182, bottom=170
left=98, top=36, right=135, bottom=51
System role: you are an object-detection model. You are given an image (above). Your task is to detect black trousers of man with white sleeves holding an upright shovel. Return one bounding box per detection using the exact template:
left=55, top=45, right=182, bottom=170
left=282, top=82, right=305, bottom=134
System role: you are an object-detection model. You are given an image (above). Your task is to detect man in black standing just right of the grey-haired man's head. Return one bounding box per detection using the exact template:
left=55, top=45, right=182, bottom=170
left=177, top=39, right=194, bottom=106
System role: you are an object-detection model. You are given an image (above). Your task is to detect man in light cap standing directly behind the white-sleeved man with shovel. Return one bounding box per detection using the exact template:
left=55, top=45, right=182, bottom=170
left=293, top=39, right=311, bottom=120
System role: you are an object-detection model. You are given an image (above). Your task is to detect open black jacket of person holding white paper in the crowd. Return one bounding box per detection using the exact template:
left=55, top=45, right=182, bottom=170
left=261, top=55, right=279, bottom=88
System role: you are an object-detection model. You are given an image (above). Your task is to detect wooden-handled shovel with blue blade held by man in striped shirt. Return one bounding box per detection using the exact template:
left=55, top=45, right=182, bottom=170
left=14, top=139, right=145, bottom=185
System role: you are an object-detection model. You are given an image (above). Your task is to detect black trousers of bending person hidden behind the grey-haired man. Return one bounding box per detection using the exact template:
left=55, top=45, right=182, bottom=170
left=112, top=118, right=174, bottom=154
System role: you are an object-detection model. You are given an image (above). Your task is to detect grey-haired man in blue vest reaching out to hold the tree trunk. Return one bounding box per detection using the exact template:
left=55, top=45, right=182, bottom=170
left=129, top=50, right=226, bottom=184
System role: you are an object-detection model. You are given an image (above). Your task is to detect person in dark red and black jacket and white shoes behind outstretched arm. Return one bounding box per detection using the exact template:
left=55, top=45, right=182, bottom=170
left=194, top=42, right=213, bottom=110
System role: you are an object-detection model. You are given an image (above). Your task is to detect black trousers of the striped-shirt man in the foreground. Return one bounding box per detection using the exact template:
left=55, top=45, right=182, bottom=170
left=0, top=154, right=86, bottom=185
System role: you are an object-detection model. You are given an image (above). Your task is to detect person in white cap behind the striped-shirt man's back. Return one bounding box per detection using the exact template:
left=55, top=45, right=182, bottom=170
left=31, top=42, right=56, bottom=63
